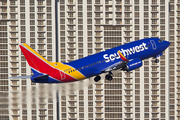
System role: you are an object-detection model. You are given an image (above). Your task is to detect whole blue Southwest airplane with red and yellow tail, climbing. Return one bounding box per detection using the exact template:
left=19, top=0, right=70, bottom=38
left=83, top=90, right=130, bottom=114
left=11, top=38, right=170, bottom=83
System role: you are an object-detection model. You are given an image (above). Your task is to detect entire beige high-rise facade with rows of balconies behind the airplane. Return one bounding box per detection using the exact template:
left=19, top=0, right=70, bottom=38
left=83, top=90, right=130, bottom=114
left=0, top=0, right=173, bottom=120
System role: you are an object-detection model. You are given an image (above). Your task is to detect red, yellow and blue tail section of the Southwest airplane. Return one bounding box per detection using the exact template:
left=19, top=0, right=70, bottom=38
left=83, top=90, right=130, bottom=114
left=11, top=43, right=77, bottom=83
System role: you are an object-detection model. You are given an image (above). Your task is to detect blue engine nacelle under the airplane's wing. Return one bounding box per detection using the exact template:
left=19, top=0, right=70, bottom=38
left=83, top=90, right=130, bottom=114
left=123, top=58, right=142, bottom=72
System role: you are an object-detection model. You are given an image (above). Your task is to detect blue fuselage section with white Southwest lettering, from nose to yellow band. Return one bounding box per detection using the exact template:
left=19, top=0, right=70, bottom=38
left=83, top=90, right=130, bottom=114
left=65, top=38, right=170, bottom=78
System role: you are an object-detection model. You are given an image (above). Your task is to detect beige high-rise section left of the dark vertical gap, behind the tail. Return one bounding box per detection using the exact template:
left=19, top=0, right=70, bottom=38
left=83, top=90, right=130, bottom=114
left=0, top=0, right=56, bottom=120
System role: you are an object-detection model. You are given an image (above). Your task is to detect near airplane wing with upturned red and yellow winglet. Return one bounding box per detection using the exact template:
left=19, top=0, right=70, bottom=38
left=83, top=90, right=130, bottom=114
left=101, top=51, right=129, bottom=73
